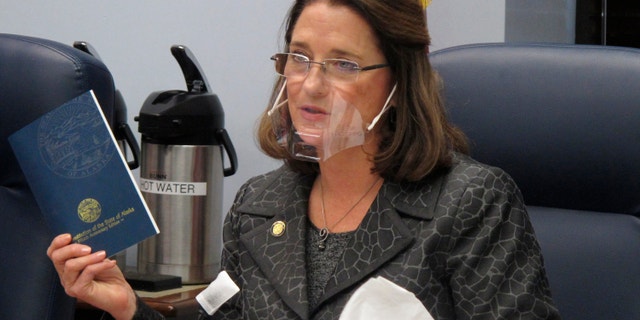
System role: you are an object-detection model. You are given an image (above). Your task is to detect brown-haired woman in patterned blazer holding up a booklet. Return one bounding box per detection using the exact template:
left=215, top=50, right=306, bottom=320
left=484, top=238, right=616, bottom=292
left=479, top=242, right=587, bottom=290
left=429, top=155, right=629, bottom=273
left=48, top=0, right=558, bottom=319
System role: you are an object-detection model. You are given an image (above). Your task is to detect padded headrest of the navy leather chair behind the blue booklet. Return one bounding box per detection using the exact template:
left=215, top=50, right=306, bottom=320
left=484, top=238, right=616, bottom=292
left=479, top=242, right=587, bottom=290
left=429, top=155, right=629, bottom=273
left=0, top=33, right=115, bottom=186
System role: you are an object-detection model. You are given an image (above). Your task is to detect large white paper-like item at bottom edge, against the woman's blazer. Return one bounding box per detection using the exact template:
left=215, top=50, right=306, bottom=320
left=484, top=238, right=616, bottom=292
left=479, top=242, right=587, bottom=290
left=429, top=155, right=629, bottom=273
left=340, top=277, right=433, bottom=320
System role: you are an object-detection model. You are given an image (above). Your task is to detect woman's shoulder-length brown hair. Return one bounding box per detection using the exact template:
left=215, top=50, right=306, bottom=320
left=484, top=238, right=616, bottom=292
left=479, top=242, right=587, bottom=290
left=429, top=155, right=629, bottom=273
left=257, top=0, right=468, bottom=181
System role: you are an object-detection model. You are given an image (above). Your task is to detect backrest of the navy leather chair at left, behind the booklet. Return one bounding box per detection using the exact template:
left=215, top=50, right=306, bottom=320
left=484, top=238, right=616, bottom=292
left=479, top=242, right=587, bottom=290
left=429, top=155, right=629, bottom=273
left=0, top=34, right=115, bottom=319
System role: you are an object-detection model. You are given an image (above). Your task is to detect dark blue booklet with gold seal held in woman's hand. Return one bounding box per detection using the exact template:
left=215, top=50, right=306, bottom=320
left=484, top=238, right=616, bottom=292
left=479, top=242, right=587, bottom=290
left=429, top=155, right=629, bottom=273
left=9, top=91, right=159, bottom=256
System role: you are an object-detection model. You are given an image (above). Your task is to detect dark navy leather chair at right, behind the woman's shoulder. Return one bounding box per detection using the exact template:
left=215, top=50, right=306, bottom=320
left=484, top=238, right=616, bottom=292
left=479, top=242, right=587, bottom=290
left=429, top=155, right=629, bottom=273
left=430, top=44, right=640, bottom=320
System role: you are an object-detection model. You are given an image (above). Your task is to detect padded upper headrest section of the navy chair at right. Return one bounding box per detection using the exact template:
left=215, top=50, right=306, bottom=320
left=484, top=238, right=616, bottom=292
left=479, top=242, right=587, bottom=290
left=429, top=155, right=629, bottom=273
left=430, top=43, right=640, bottom=214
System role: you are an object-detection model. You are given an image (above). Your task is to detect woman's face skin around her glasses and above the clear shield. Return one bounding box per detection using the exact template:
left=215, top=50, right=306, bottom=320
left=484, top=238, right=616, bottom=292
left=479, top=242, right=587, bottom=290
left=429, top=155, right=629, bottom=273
left=287, top=1, right=393, bottom=154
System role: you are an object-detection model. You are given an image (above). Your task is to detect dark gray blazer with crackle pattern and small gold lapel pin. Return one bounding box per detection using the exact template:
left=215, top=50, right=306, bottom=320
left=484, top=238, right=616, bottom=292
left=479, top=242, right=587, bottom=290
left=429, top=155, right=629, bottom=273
left=200, top=155, right=559, bottom=319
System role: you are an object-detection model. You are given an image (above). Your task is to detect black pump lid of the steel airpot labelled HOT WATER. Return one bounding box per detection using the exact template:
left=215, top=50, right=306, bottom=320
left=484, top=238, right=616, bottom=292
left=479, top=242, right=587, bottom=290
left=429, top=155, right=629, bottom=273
left=135, top=45, right=224, bottom=145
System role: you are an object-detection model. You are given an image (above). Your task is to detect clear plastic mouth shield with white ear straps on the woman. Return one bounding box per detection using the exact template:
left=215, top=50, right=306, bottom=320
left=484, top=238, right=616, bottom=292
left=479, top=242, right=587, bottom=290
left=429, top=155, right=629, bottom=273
left=267, top=80, right=396, bottom=162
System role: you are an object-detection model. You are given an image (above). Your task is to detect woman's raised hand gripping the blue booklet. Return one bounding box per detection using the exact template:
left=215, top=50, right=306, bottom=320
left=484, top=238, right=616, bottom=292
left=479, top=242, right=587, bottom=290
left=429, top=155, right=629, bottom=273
left=47, top=234, right=136, bottom=319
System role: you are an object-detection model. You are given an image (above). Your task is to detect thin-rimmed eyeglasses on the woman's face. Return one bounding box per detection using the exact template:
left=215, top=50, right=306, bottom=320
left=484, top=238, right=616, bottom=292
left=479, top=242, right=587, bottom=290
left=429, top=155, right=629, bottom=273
left=271, top=53, right=389, bottom=82
